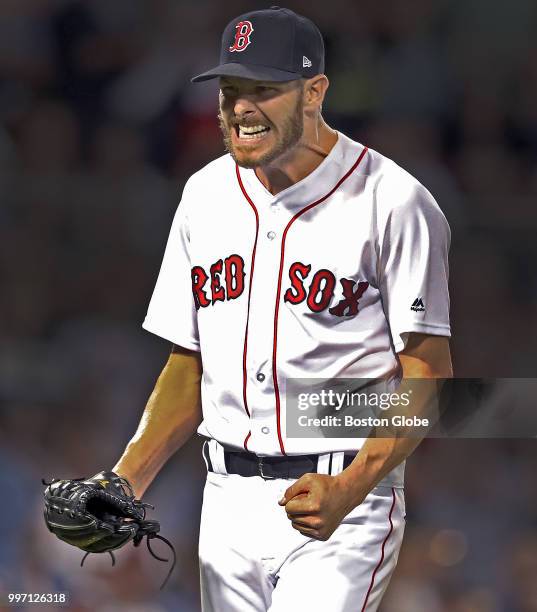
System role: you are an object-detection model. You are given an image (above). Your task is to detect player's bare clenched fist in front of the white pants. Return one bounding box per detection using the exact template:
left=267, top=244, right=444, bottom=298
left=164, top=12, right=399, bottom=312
left=278, top=474, right=365, bottom=541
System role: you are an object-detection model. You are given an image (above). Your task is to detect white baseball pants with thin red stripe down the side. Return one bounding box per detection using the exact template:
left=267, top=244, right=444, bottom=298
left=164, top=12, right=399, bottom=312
left=199, top=464, right=405, bottom=612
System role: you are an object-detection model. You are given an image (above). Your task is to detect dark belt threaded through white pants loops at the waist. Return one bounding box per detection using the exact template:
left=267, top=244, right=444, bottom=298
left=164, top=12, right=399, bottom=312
left=203, top=443, right=355, bottom=480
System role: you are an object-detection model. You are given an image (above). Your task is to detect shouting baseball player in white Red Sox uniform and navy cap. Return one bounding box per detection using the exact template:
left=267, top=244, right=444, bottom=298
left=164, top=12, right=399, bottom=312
left=114, top=7, right=451, bottom=612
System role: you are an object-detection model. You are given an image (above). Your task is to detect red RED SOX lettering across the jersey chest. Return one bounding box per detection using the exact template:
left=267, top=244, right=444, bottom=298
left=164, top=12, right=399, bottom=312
left=192, top=254, right=369, bottom=317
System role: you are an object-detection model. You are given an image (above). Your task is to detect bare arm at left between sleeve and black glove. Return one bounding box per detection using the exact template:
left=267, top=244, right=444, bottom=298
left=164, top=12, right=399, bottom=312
left=113, top=354, right=202, bottom=498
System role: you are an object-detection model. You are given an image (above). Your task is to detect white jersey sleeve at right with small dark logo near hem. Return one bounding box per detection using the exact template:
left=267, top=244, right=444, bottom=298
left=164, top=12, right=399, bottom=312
left=378, top=177, right=451, bottom=352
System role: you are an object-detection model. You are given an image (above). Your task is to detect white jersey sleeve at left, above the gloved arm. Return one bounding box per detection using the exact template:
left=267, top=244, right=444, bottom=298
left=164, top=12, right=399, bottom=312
left=142, top=183, right=200, bottom=351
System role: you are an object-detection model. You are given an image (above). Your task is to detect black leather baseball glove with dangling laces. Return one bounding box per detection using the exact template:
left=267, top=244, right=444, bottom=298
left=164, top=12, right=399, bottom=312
left=42, top=472, right=176, bottom=589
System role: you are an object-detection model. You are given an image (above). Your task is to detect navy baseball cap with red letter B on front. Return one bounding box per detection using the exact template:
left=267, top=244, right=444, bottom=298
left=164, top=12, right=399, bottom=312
left=191, top=6, right=324, bottom=83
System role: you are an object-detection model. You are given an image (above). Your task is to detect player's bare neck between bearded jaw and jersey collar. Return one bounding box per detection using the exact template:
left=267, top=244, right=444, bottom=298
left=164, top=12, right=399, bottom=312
left=255, top=119, right=338, bottom=195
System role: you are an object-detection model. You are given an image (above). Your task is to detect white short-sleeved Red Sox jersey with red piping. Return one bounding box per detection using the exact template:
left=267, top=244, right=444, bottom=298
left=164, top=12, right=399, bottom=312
left=143, top=133, right=450, bottom=485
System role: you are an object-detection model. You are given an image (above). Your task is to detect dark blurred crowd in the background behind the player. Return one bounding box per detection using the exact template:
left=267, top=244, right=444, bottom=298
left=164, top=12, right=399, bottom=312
left=0, top=0, right=537, bottom=612
